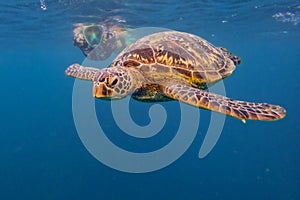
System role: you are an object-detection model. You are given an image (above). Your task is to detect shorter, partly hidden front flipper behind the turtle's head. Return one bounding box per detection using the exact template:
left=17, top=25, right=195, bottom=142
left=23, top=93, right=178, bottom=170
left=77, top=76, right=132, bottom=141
left=65, top=64, right=99, bottom=81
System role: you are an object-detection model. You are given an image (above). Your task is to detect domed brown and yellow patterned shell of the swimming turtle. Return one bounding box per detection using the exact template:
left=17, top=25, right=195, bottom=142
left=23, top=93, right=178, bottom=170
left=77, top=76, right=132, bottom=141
left=112, top=31, right=235, bottom=85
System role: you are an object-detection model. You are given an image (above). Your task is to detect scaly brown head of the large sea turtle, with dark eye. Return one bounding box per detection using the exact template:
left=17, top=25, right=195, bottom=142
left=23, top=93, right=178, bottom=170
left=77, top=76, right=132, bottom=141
left=93, top=67, right=137, bottom=99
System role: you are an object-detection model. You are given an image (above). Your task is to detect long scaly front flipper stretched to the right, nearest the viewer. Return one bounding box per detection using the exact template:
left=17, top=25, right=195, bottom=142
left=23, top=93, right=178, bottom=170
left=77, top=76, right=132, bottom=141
left=164, top=84, right=286, bottom=122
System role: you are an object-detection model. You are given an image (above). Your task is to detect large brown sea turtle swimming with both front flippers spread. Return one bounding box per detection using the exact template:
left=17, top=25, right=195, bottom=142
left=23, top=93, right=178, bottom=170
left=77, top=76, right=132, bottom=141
left=65, top=31, right=286, bottom=122
